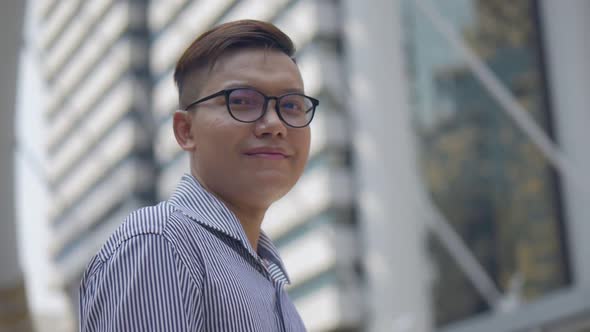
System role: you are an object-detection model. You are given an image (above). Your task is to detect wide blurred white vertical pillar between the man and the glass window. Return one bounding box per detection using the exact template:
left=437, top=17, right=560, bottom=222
left=344, top=0, right=433, bottom=332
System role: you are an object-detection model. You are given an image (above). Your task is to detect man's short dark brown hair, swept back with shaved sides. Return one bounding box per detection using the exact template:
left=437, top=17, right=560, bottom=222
left=174, top=20, right=295, bottom=99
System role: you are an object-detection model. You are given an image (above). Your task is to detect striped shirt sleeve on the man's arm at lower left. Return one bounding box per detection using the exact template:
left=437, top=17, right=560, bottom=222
left=79, top=234, right=203, bottom=332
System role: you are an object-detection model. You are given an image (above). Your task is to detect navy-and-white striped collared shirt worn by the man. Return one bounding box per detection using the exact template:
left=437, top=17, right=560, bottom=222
left=79, top=175, right=305, bottom=332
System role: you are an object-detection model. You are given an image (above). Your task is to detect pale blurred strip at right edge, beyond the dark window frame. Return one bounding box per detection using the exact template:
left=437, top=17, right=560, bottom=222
left=540, top=0, right=590, bottom=289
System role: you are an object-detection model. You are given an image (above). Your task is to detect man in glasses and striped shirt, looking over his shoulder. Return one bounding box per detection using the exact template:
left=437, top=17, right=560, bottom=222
left=80, top=20, right=318, bottom=332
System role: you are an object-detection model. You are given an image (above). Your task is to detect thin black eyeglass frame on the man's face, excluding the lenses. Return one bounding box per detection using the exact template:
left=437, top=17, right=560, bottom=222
left=184, top=87, right=320, bottom=128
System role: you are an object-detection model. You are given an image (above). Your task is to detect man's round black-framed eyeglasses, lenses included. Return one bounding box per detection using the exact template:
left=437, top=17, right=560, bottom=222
left=184, top=88, right=320, bottom=128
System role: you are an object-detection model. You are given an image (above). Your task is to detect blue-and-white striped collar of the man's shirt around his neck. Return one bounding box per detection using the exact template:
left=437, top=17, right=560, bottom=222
left=168, top=174, right=290, bottom=283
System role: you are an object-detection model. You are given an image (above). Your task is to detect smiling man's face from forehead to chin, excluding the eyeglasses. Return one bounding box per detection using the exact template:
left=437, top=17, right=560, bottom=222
left=178, top=49, right=310, bottom=208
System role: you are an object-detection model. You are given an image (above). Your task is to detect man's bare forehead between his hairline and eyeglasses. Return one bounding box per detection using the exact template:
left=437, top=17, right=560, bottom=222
left=189, top=49, right=303, bottom=95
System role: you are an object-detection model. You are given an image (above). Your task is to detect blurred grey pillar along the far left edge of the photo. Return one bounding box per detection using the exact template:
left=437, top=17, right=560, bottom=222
left=0, top=0, right=31, bottom=331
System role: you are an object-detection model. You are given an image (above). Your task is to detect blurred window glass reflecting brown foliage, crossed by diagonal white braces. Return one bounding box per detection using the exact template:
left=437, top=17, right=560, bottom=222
left=403, top=0, right=568, bottom=326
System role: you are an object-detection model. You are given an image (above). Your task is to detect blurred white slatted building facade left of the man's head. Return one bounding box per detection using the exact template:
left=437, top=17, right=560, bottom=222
left=39, top=0, right=154, bottom=296
